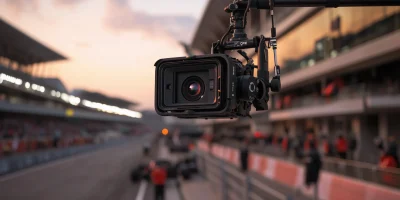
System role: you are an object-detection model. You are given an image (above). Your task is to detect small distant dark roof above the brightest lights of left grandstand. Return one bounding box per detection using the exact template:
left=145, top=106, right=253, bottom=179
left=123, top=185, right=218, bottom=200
left=71, top=89, right=137, bottom=108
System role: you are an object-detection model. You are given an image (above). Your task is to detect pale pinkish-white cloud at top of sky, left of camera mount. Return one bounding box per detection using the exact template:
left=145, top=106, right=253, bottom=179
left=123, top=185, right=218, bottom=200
left=104, top=0, right=196, bottom=42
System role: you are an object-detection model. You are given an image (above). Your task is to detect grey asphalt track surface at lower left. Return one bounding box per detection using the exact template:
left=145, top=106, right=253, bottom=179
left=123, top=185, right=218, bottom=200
left=0, top=134, right=174, bottom=200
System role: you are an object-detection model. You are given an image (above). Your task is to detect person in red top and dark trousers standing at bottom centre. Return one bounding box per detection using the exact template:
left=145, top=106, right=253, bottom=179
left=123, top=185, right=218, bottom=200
left=150, top=161, right=167, bottom=200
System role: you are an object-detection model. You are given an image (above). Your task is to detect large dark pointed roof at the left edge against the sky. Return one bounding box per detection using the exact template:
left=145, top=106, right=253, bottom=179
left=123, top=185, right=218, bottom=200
left=0, top=18, right=66, bottom=65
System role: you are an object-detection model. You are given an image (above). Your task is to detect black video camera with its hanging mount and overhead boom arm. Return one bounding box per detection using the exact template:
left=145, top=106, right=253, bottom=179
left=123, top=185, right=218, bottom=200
left=155, top=0, right=400, bottom=118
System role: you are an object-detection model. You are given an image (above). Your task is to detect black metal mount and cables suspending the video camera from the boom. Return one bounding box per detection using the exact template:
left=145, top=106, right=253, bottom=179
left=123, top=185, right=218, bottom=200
left=211, top=0, right=281, bottom=116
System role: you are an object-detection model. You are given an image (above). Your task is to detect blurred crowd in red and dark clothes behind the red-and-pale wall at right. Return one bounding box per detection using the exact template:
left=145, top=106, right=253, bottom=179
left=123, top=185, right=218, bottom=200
left=203, top=129, right=400, bottom=168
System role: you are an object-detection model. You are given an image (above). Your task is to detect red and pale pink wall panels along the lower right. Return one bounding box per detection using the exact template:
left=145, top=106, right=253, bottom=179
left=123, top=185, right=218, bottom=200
left=198, top=141, right=400, bottom=200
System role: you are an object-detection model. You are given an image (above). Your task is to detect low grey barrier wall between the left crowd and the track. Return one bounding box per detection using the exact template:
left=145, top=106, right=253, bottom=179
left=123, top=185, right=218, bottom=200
left=0, top=140, right=126, bottom=176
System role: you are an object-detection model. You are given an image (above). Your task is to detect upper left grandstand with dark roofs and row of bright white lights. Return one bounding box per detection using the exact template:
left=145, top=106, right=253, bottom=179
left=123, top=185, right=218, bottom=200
left=0, top=17, right=141, bottom=122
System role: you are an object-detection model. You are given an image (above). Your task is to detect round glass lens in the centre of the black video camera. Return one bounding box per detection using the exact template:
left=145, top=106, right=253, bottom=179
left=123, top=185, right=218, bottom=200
left=182, top=76, right=204, bottom=101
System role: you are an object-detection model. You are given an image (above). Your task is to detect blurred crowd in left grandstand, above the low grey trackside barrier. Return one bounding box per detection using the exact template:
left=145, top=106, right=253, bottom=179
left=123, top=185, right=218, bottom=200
left=0, top=116, right=143, bottom=157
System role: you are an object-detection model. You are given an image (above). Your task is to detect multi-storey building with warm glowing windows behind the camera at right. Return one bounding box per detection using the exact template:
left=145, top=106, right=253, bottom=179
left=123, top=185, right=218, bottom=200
left=191, top=0, right=400, bottom=163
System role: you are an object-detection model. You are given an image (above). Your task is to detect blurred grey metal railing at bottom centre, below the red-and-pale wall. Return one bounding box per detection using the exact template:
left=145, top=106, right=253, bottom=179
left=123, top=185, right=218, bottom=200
left=197, top=153, right=295, bottom=200
